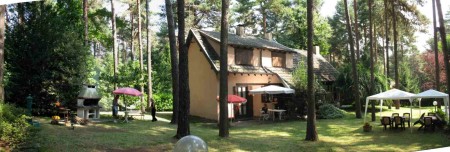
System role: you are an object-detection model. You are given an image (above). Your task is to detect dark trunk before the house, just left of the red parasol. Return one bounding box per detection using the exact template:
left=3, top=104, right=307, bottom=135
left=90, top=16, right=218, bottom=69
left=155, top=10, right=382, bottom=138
left=219, top=0, right=230, bottom=137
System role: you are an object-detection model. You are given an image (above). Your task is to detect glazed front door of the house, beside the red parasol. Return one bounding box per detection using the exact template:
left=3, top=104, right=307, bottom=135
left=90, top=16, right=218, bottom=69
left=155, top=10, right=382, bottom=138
left=234, top=86, right=253, bottom=119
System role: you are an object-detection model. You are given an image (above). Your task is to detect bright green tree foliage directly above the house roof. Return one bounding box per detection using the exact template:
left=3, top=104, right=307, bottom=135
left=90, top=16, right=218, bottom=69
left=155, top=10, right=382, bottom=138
left=231, top=0, right=332, bottom=54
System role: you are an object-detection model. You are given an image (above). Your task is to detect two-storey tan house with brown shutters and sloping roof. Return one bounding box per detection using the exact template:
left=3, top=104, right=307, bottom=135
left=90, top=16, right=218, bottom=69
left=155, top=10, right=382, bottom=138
left=186, top=27, right=337, bottom=120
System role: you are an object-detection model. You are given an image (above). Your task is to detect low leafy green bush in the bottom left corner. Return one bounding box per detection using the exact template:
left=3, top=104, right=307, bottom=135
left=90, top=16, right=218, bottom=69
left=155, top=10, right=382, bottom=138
left=0, top=104, right=31, bottom=148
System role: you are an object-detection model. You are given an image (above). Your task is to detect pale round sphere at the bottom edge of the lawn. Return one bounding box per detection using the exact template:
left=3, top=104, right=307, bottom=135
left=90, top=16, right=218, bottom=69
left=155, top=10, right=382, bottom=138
left=173, top=135, right=208, bottom=152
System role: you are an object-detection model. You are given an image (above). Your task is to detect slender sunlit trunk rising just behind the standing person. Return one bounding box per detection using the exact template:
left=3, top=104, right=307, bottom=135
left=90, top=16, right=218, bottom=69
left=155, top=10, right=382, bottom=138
left=145, top=0, right=155, bottom=108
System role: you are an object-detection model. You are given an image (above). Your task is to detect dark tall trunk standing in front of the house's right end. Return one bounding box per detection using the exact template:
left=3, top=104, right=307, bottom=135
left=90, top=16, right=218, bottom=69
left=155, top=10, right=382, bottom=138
left=305, top=0, right=319, bottom=141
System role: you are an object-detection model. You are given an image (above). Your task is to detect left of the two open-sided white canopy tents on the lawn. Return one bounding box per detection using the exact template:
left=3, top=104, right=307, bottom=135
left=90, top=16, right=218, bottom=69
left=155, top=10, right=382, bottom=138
left=364, top=89, right=415, bottom=123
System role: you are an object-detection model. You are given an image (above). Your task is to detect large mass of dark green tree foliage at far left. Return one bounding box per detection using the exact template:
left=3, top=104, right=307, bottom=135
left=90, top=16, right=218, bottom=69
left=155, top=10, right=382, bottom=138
left=5, top=1, right=92, bottom=114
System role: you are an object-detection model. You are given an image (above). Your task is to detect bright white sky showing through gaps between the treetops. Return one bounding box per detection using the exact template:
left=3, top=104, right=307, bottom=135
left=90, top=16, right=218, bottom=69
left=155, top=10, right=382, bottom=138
left=118, top=0, right=450, bottom=51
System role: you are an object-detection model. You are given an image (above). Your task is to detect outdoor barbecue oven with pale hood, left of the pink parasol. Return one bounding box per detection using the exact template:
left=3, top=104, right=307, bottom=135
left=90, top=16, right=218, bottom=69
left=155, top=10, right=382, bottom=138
left=77, top=85, right=102, bottom=119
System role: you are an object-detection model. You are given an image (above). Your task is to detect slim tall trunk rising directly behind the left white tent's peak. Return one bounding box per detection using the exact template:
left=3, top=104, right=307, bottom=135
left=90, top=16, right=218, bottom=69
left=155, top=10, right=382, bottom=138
left=392, top=0, right=400, bottom=109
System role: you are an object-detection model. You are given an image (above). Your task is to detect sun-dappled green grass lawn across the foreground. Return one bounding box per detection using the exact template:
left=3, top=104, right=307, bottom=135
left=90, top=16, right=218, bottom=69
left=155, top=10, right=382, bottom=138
left=32, top=108, right=450, bottom=151
